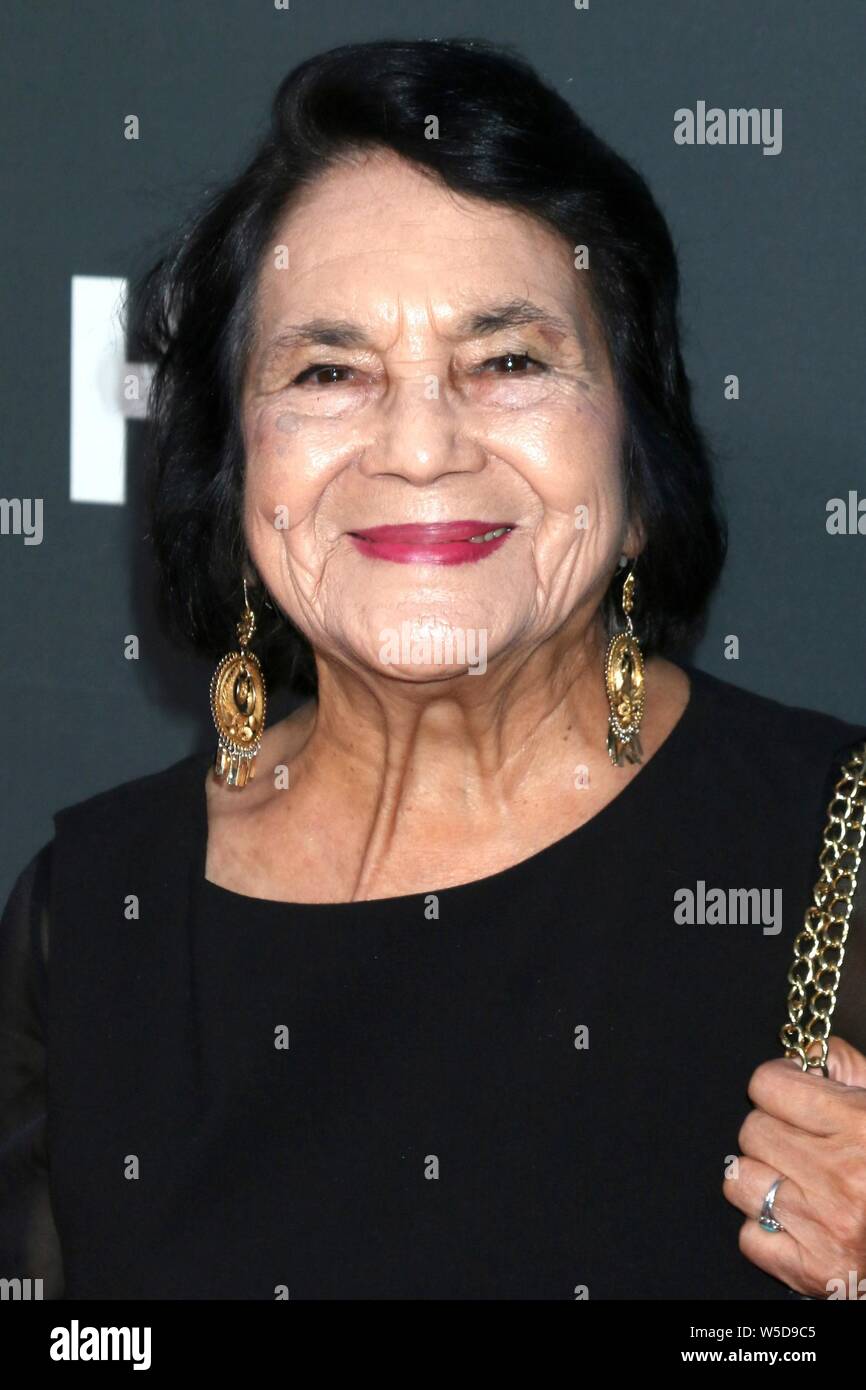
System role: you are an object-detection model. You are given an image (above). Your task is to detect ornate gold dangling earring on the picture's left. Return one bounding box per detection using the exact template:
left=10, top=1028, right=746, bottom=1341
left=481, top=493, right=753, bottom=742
left=210, top=580, right=265, bottom=787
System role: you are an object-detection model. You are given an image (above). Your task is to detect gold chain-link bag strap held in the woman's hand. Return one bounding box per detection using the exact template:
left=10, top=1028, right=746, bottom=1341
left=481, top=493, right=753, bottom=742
left=778, top=742, right=866, bottom=1076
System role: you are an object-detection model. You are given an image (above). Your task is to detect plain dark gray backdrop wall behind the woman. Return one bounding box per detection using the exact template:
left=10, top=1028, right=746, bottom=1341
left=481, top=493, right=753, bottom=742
left=0, top=0, right=866, bottom=901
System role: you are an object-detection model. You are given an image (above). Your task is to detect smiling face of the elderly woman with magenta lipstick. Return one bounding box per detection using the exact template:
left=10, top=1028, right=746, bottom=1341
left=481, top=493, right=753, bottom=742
left=243, top=152, right=632, bottom=680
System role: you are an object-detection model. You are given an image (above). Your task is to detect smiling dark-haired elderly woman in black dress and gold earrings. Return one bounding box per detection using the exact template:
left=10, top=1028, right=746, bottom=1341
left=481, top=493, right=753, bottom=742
left=1, top=42, right=866, bottom=1300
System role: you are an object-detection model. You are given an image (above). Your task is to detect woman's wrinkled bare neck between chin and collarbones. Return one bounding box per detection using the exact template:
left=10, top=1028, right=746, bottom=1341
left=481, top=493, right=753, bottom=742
left=302, top=616, right=609, bottom=813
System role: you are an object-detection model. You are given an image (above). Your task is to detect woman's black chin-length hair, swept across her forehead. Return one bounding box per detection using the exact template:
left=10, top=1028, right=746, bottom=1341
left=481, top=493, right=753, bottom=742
left=131, top=39, right=727, bottom=691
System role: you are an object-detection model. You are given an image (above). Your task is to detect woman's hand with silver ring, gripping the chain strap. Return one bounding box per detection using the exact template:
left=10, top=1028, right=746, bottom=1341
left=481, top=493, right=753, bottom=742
left=723, top=1037, right=866, bottom=1298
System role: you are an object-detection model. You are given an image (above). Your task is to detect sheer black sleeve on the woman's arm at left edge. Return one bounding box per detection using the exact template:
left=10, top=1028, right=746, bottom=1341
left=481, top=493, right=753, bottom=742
left=0, top=842, right=64, bottom=1298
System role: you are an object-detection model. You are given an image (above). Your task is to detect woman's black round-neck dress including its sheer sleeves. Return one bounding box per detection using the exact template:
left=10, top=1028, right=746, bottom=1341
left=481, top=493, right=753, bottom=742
left=0, top=666, right=866, bottom=1300
